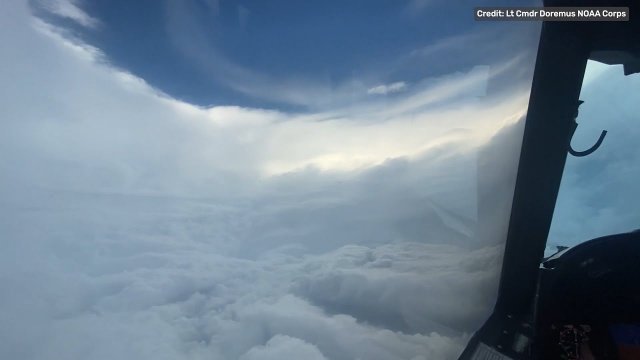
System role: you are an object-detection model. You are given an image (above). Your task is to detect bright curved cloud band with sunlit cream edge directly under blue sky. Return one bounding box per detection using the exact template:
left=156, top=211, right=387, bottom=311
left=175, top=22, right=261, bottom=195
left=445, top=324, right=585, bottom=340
left=3, top=6, right=525, bottom=192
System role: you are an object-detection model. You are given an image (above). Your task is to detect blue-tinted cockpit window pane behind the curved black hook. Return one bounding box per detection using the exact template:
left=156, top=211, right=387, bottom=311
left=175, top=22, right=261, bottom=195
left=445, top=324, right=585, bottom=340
left=547, top=61, right=640, bottom=252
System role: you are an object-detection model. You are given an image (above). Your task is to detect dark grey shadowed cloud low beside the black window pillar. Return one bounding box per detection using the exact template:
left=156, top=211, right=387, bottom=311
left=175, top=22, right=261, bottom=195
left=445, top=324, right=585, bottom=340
left=294, top=243, right=503, bottom=335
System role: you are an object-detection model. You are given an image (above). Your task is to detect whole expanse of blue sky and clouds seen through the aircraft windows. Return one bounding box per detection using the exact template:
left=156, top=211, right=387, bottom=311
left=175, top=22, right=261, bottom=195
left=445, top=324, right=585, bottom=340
left=0, top=0, right=637, bottom=360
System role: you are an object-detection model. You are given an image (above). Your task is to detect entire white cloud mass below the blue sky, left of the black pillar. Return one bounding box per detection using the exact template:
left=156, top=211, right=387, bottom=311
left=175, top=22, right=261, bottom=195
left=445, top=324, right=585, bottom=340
left=0, top=3, right=526, bottom=360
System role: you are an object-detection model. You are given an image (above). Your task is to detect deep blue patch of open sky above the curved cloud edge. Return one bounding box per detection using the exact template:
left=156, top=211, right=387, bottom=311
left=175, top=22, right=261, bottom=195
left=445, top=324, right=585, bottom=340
left=31, top=0, right=530, bottom=111
